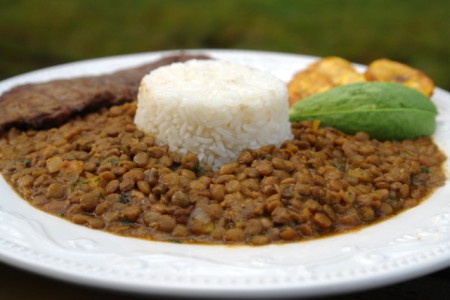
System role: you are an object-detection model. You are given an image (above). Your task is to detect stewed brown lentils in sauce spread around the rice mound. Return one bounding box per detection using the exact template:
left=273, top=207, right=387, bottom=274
left=0, top=102, right=446, bottom=245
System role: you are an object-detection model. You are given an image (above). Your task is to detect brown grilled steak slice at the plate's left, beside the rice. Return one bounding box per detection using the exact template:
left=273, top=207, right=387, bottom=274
left=0, top=54, right=209, bottom=134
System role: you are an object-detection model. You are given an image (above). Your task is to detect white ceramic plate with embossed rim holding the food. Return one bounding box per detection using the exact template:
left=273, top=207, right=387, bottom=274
left=0, top=50, right=450, bottom=298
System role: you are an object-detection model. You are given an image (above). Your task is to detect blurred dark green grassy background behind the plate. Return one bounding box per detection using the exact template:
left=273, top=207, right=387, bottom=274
left=0, top=0, right=450, bottom=90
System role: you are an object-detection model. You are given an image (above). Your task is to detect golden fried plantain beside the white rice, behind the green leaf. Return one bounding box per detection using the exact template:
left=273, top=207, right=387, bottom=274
left=288, top=56, right=365, bottom=106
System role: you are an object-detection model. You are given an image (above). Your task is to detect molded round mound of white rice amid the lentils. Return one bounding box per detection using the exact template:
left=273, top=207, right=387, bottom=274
left=135, top=60, right=292, bottom=169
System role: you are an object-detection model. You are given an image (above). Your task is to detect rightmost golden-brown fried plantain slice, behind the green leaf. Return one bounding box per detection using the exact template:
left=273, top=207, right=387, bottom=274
left=364, top=58, right=434, bottom=97
